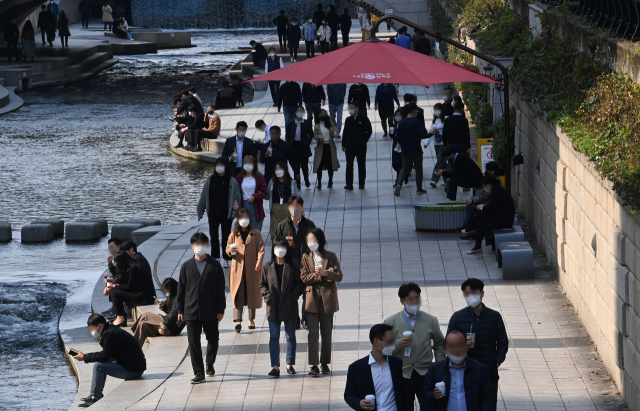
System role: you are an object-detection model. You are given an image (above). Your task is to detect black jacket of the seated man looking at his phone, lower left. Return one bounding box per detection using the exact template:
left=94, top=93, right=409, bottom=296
left=84, top=324, right=147, bottom=372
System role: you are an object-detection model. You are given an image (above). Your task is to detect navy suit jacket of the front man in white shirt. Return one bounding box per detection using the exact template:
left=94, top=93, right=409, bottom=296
left=344, top=355, right=413, bottom=411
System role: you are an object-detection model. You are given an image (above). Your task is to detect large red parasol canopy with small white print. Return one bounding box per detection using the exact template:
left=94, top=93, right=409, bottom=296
left=247, top=39, right=500, bottom=86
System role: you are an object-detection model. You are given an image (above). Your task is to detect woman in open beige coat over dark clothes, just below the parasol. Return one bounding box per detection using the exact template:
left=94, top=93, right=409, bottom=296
left=313, top=110, right=340, bottom=190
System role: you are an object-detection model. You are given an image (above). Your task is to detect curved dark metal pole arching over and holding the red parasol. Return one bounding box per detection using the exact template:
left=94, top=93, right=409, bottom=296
left=371, top=15, right=512, bottom=192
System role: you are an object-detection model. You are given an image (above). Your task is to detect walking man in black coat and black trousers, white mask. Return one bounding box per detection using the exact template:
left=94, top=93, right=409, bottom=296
left=176, top=232, right=226, bottom=384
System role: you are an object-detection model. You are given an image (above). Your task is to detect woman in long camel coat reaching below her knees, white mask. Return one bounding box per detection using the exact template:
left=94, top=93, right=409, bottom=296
left=226, top=208, right=264, bottom=333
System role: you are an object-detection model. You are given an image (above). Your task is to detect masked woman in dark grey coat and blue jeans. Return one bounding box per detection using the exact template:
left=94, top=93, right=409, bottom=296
left=260, top=237, right=304, bottom=378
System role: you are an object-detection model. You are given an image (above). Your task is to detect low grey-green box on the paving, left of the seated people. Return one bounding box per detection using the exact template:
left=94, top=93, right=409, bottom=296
left=413, top=202, right=467, bottom=230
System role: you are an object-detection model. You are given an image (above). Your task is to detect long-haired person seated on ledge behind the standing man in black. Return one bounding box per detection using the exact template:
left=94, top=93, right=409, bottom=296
left=131, top=278, right=186, bottom=347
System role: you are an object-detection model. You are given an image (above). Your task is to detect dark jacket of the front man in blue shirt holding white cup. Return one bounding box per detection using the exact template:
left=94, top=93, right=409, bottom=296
left=424, top=358, right=495, bottom=411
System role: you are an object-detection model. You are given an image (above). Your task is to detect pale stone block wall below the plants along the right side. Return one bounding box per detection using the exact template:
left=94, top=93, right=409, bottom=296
left=511, top=92, right=640, bottom=410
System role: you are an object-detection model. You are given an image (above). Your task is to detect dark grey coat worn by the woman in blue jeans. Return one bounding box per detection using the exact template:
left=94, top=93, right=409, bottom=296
left=260, top=261, right=304, bottom=322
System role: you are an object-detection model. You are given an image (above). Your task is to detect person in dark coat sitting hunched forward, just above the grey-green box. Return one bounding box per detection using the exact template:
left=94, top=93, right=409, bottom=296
left=436, top=147, right=482, bottom=202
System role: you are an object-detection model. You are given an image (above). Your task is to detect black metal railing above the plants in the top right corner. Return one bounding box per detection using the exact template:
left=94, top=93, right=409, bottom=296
left=541, top=0, right=640, bottom=41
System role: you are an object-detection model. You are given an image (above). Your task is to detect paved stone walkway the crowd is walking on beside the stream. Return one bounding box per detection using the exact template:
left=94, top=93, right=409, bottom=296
left=63, top=82, right=623, bottom=411
